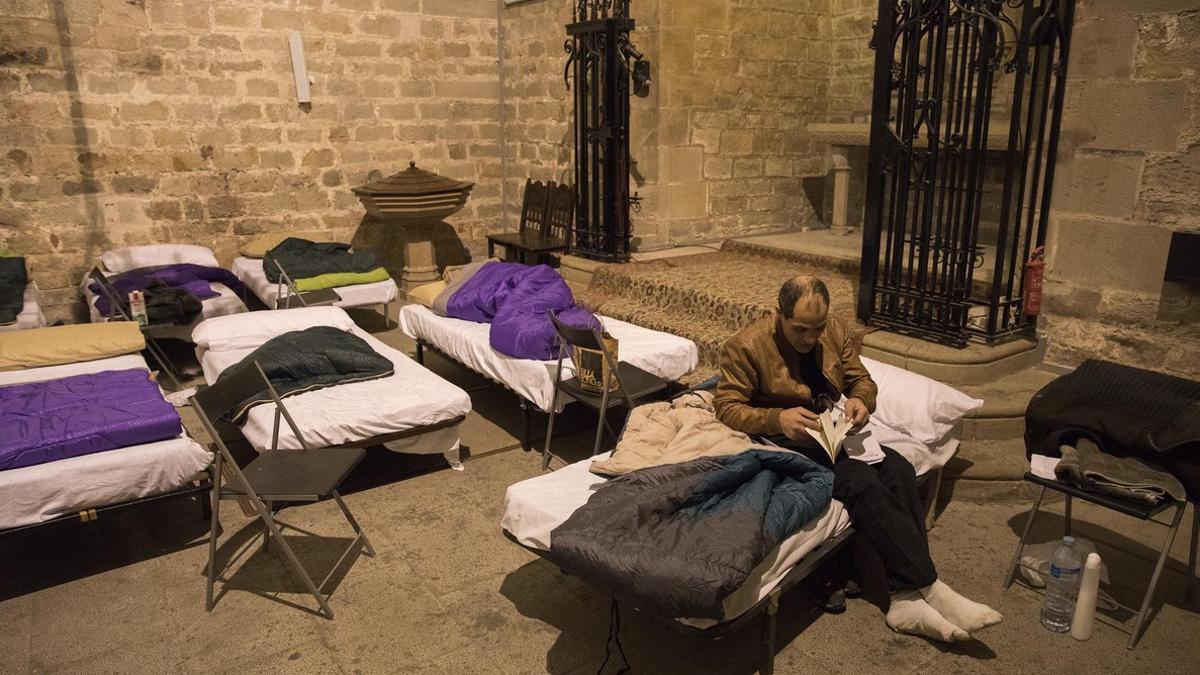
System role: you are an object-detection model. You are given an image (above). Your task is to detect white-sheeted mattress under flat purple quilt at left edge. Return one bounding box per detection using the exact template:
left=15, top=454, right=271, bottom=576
left=0, top=354, right=211, bottom=530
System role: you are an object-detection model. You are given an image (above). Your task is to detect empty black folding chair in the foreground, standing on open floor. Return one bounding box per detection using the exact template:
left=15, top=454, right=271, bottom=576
left=191, top=362, right=374, bottom=619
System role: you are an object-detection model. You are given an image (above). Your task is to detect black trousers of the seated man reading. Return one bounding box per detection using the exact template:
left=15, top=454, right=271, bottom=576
left=768, top=435, right=937, bottom=591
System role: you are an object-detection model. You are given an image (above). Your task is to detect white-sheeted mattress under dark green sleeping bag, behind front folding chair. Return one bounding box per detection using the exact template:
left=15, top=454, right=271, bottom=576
left=198, top=324, right=470, bottom=459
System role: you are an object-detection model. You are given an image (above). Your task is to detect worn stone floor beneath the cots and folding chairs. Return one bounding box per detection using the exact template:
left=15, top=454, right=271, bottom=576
left=0, top=312, right=1200, bottom=674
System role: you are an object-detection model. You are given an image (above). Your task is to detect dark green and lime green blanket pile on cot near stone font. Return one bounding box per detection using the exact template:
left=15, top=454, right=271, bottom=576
left=263, top=237, right=391, bottom=292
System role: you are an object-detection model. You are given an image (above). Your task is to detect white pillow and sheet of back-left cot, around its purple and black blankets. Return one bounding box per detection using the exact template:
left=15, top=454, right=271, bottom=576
left=83, top=244, right=250, bottom=342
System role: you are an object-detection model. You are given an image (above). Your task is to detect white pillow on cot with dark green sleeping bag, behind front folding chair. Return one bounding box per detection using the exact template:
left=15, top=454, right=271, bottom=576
left=192, top=306, right=354, bottom=352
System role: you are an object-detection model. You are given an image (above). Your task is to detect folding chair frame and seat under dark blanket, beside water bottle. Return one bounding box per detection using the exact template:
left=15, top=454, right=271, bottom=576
left=1004, top=473, right=1200, bottom=649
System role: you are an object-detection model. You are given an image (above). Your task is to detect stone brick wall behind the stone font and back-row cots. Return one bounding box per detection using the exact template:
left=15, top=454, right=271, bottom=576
left=0, top=0, right=502, bottom=321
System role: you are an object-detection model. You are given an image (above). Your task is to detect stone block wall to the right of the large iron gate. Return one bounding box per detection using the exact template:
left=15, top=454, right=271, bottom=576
left=1044, top=0, right=1200, bottom=377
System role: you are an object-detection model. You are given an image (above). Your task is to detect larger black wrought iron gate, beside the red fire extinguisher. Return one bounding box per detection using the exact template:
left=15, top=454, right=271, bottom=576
left=858, top=0, right=1074, bottom=346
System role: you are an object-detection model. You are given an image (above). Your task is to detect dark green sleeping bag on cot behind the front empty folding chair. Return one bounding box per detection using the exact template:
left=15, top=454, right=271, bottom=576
left=217, top=325, right=394, bottom=423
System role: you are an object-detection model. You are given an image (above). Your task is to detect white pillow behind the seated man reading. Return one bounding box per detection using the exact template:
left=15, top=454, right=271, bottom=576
left=863, top=357, right=983, bottom=448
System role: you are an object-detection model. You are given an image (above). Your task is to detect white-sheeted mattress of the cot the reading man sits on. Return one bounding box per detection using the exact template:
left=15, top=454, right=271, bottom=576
left=500, top=453, right=850, bottom=628
